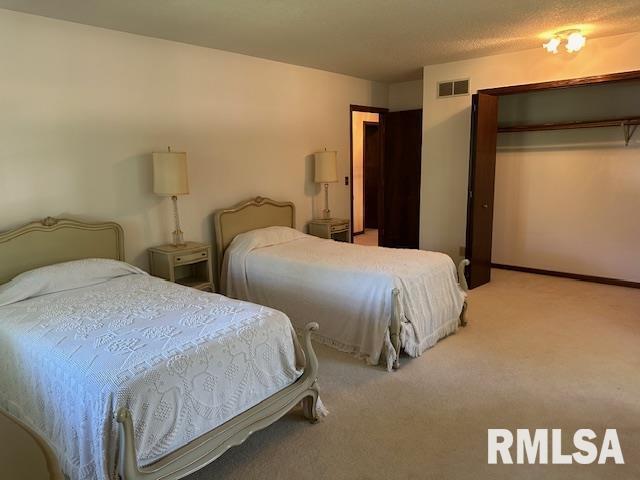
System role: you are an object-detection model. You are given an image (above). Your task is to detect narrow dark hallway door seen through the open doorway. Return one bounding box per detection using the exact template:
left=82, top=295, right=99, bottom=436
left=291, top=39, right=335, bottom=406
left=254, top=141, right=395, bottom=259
left=362, top=122, right=380, bottom=228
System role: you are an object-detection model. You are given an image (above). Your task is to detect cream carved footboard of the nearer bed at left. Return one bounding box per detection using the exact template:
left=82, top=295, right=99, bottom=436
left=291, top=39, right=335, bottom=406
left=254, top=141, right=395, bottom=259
left=116, top=323, right=318, bottom=480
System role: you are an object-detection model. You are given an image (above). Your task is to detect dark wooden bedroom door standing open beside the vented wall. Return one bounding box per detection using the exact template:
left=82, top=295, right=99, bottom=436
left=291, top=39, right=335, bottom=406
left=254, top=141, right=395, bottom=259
left=379, top=110, right=422, bottom=248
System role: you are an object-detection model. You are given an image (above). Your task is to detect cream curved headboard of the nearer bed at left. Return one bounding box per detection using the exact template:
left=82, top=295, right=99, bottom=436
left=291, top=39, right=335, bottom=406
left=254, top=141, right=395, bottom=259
left=0, top=217, right=124, bottom=284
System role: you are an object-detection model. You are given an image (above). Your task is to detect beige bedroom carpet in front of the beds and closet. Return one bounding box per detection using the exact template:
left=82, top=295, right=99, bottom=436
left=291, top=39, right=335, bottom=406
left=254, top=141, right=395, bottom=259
left=189, top=270, right=640, bottom=480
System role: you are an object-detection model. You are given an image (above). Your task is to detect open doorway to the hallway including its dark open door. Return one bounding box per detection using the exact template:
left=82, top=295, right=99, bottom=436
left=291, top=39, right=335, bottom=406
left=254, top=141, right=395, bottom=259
left=350, top=105, right=422, bottom=248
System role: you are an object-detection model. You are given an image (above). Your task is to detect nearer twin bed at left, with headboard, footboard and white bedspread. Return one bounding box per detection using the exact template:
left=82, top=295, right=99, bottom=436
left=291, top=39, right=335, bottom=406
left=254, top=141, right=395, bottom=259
left=0, top=218, right=321, bottom=480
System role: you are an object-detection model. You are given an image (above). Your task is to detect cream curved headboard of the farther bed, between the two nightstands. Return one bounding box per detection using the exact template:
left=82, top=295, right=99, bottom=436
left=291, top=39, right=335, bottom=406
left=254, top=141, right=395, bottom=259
left=213, top=197, right=296, bottom=275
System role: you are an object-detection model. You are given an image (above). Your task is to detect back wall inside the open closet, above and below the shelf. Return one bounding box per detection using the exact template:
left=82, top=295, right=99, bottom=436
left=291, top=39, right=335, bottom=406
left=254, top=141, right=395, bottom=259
left=492, top=82, right=640, bottom=282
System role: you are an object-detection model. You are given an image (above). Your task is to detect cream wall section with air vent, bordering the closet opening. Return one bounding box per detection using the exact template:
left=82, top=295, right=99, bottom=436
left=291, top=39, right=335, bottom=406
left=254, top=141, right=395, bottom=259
left=420, top=33, right=640, bottom=259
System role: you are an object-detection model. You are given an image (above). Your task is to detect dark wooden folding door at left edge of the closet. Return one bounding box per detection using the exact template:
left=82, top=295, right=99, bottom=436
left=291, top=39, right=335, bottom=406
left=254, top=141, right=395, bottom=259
left=465, top=93, right=498, bottom=288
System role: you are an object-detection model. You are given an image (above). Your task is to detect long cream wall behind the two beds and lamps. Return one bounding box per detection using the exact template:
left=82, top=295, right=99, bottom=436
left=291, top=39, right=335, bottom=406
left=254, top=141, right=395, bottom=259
left=0, top=10, right=388, bottom=266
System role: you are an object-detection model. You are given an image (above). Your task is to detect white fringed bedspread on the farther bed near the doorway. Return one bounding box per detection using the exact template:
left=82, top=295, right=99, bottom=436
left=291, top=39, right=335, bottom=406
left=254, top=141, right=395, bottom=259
left=222, top=227, right=465, bottom=368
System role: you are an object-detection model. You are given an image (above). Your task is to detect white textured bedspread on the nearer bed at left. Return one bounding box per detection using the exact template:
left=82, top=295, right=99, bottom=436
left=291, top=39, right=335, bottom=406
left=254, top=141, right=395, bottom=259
left=0, top=260, right=303, bottom=480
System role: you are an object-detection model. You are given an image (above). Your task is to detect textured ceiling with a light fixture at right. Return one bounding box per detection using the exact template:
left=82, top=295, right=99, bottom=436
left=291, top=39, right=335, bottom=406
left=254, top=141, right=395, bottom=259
left=0, top=0, right=640, bottom=82
